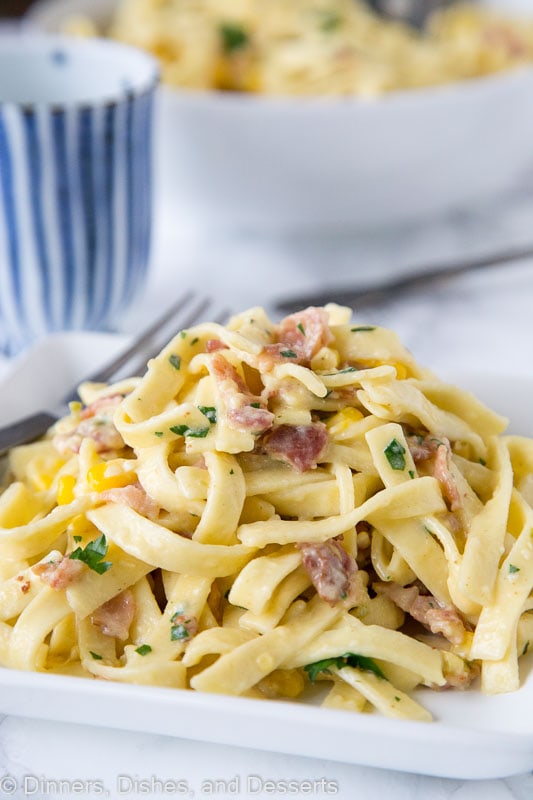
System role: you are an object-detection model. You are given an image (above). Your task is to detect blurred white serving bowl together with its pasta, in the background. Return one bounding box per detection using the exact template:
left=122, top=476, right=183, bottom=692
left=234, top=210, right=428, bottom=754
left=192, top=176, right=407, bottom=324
left=25, top=0, right=533, bottom=234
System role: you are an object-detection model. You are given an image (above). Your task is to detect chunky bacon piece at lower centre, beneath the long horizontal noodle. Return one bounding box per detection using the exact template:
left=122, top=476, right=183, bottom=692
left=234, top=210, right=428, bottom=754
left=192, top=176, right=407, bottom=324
left=299, top=539, right=357, bottom=606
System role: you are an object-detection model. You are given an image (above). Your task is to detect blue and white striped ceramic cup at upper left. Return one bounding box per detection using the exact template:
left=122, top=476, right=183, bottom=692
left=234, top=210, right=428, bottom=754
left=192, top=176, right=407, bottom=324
left=0, top=34, right=158, bottom=355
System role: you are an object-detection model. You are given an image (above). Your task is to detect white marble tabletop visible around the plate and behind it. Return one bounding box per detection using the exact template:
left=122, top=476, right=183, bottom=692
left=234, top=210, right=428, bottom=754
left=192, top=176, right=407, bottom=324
left=0, top=184, right=533, bottom=800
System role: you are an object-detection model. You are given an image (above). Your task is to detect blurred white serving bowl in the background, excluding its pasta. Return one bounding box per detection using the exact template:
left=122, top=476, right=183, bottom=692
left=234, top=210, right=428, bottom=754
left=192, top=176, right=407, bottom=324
left=26, top=0, right=533, bottom=231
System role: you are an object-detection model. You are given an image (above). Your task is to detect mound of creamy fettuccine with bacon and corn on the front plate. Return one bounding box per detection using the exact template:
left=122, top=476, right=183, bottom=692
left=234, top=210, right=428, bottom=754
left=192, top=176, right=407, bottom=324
left=0, top=305, right=533, bottom=720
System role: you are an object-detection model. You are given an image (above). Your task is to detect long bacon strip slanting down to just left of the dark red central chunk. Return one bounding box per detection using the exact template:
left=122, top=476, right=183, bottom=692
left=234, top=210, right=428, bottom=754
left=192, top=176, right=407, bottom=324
left=211, top=353, right=274, bottom=433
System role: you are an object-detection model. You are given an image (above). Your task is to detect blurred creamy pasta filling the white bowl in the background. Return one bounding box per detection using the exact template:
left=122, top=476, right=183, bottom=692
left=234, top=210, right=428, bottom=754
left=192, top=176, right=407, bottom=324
left=65, top=0, right=533, bottom=96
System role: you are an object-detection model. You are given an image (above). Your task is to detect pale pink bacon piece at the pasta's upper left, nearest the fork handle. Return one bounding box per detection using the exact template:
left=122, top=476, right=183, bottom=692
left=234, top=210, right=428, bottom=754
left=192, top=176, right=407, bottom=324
left=53, top=394, right=124, bottom=455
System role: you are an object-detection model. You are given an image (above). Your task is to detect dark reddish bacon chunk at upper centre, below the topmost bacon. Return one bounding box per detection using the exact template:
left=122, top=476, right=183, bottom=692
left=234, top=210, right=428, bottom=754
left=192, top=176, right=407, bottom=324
left=263, top=422, right=328, bottom=472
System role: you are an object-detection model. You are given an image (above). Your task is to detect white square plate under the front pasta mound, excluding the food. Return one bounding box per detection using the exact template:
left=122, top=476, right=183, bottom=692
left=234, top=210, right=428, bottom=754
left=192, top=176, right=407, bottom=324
left=0, top=333, right=533, bottom=779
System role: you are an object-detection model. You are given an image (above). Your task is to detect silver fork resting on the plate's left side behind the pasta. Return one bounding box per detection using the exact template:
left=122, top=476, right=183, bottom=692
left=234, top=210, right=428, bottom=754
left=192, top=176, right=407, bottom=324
left=0, top=291, right=228, bottom=457
